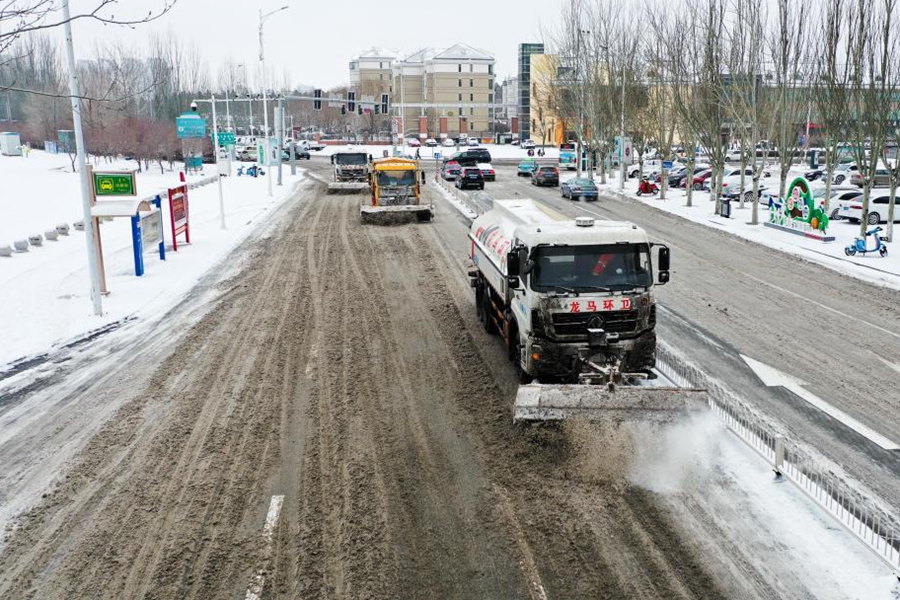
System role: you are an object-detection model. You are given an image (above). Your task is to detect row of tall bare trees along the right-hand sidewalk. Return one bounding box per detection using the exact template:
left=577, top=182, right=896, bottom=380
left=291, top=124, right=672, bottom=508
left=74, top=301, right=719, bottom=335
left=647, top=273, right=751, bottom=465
left=532, top=0, right=900, bottom=235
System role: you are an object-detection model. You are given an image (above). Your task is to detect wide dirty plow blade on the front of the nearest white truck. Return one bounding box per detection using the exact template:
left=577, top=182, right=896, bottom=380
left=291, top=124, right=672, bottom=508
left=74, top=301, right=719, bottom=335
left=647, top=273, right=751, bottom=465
left=513, top=384, right=708, bottom=423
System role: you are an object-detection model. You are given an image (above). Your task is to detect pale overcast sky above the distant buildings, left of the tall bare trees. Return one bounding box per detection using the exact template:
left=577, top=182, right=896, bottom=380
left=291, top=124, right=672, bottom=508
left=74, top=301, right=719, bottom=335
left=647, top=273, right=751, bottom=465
left=72, top=0, right=562, bottom=88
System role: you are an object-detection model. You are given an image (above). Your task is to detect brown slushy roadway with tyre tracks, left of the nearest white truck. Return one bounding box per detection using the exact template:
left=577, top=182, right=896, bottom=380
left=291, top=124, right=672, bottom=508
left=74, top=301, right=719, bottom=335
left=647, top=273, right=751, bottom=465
left=0, top=165, right=896, bottom=600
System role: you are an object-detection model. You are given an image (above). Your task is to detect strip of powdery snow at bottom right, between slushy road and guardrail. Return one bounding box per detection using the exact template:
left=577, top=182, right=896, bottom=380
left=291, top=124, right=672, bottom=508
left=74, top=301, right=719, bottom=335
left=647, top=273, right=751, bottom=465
left=628, top=414, right=900, bottom=600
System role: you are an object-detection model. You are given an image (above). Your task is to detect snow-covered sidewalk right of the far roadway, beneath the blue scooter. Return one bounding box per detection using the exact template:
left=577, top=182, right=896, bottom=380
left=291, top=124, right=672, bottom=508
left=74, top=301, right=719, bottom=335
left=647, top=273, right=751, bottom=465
left=596, top=169, right=900, bottom=289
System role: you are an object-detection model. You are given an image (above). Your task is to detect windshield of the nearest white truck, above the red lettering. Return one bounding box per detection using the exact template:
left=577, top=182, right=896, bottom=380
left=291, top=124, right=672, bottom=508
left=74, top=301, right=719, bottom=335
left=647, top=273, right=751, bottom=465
left=531, top=244, right=653, bottom=292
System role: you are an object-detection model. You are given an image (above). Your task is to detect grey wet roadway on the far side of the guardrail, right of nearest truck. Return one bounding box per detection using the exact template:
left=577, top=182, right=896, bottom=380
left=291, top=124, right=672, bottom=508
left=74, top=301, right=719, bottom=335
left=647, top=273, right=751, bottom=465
left=458, top=167, right=900, bottom=514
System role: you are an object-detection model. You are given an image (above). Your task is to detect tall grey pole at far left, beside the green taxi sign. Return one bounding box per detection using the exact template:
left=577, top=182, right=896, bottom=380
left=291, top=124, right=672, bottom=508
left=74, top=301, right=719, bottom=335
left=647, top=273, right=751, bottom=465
left=62, top=0, right=103, bottom=317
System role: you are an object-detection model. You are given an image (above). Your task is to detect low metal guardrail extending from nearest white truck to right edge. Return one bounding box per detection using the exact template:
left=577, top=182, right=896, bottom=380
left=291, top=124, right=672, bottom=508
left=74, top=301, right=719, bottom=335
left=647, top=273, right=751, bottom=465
left=656, top=340, right=900, bottom=577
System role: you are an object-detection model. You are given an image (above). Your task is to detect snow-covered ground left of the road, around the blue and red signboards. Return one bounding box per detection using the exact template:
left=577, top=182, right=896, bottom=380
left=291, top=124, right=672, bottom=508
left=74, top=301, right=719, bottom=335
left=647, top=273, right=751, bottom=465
left=0, top=151, right=304, bottom=371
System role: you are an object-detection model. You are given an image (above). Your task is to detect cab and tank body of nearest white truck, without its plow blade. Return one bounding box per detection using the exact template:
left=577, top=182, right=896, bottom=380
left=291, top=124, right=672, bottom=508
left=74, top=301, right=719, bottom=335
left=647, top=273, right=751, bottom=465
left=469, top=200, right=669, bottom=383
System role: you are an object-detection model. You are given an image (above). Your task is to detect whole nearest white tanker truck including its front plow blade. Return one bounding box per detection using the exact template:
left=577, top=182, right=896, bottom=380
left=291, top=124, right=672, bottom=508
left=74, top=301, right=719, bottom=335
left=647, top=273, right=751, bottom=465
left=469, top=200, right=701, bottom=421
